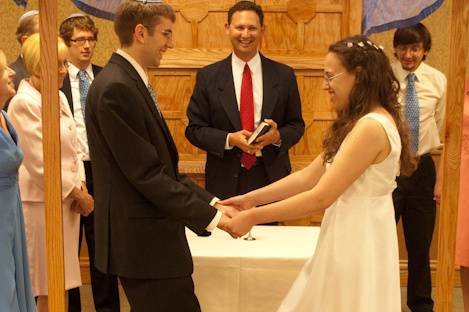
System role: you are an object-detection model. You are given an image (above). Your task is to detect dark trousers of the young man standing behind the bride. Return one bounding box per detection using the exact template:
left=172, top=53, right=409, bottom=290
left=393, top=154, right=436, bottom=312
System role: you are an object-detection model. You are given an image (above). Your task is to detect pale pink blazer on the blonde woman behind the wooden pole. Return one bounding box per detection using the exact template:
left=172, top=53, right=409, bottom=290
left=8, top=80, right=85, bottom=202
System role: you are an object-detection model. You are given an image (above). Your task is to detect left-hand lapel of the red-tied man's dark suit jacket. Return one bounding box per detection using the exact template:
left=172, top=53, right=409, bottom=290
left=217, top=55, right=241, bottom=130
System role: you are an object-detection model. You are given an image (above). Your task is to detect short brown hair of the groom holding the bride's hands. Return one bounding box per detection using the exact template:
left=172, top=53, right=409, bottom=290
left=114, top=0, right=176, bottom=47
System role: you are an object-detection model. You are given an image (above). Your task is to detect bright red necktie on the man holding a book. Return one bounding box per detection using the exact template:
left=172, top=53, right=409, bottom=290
left=239, top=63, right=256, bottom=170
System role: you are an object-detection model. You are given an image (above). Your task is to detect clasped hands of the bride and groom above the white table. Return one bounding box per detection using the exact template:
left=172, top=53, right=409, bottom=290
left=215, top=195, right=255, bottom=238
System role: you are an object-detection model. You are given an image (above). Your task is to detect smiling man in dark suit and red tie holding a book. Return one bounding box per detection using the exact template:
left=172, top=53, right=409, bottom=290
left=186, top=1, right=305, bottom=210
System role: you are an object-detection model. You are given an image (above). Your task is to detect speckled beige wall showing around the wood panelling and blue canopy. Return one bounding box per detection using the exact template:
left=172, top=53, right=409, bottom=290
left=0, top=0, right=469, bottom=79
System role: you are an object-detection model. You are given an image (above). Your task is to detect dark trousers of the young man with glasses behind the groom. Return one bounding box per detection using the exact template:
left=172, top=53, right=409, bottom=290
left=68, top=161, right=120, bottom=312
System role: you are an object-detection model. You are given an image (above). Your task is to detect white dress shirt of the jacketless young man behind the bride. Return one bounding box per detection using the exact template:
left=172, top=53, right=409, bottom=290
left=392, top=62, right=447, bottom=155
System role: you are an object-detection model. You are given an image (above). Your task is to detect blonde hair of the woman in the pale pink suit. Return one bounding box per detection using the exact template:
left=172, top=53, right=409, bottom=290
left=21, top=34, right=68, bottom=77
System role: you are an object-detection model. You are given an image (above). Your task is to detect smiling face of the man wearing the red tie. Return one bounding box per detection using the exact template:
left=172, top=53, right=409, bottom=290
left=225, top=10, right=265, bottom=62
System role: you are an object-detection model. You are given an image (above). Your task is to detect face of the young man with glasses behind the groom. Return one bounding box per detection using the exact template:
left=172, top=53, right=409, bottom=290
left=68, top=27, right=96, bottom=68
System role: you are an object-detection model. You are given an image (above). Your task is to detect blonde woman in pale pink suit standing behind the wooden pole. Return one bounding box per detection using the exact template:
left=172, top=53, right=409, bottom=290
left=8, top=34, right=93, bottom=312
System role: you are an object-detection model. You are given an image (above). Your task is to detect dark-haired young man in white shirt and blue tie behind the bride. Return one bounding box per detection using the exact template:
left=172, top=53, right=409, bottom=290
left=392, top=23, right=446, bottom=312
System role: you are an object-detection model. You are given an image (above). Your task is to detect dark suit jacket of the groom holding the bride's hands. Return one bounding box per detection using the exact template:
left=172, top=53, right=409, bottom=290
left=85, top=54, right=216, bottom=279
